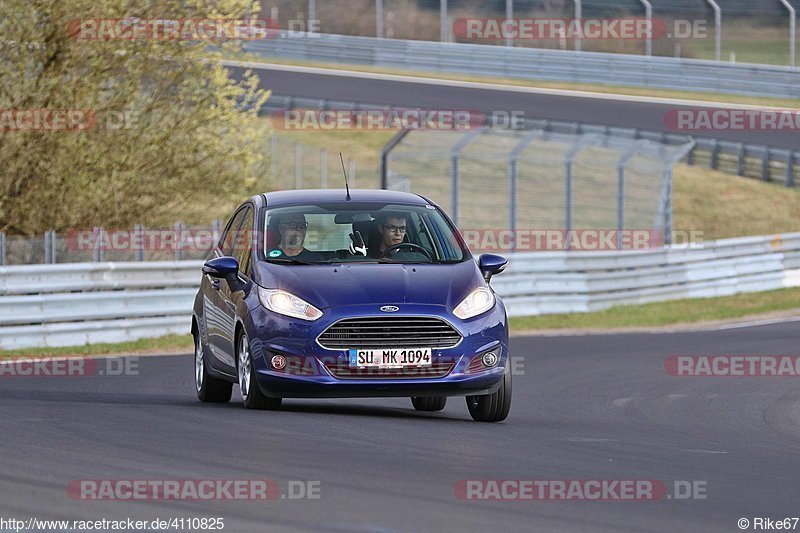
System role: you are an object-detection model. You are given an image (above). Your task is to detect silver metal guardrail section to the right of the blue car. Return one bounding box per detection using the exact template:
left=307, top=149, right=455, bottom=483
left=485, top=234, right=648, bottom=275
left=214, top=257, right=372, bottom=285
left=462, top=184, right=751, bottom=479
left=492, top=233, right=800, bottom=316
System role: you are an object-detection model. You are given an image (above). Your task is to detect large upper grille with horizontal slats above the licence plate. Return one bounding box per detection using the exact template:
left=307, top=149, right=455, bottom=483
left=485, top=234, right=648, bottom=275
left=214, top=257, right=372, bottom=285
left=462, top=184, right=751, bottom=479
left=319, top=316, right=461, bottom=350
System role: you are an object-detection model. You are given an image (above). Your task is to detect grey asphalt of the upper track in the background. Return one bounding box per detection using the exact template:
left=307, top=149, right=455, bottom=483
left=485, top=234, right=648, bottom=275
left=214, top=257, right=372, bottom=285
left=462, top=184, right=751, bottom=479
left=230, top=67, right=798, bottom=150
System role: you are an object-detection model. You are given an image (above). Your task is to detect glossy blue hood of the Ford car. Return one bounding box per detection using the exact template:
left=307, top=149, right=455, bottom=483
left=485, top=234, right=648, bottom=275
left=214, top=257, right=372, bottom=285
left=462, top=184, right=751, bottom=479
left=255, top=260, right=486, bottom=309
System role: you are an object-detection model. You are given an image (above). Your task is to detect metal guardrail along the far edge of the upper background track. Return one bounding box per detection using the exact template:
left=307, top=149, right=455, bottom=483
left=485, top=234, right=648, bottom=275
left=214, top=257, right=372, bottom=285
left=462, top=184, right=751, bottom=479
left=245, top=33, right=800, bottom=98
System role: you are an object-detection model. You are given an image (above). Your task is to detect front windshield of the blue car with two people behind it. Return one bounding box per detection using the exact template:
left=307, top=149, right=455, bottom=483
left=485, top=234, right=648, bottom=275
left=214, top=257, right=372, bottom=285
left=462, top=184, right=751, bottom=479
left=262, top=201, right=468, bottom=264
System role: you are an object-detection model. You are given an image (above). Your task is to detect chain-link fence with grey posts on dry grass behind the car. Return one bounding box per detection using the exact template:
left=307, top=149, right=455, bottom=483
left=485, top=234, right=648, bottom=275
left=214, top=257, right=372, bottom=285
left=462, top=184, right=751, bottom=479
left=384, top=128, right=693, bottom=248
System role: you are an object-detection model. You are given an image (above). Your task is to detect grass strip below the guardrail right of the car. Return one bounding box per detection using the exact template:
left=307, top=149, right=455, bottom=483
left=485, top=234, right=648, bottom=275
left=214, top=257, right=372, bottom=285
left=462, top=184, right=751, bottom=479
left=510, top=288, right=800, bottom=332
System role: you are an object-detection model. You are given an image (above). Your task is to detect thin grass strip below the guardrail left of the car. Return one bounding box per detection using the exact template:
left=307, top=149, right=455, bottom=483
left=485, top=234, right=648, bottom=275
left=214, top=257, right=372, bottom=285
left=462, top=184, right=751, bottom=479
left=0, top=335, right=194, bottom=359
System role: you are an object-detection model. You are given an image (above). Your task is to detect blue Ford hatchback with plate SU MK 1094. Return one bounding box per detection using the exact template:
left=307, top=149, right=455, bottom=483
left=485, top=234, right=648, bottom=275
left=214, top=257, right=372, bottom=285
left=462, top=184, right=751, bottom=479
left=192, top=190, right=511, bottom=422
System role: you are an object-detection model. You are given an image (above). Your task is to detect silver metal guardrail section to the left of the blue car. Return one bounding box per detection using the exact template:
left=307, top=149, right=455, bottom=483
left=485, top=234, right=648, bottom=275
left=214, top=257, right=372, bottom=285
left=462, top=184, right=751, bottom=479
left=0, top=261, right=203, bottom=349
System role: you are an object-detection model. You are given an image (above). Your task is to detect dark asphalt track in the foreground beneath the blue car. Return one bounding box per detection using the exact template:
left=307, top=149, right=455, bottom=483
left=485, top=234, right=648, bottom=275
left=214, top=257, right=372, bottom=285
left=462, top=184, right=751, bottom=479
left=0, top=322, right=800, bottom=532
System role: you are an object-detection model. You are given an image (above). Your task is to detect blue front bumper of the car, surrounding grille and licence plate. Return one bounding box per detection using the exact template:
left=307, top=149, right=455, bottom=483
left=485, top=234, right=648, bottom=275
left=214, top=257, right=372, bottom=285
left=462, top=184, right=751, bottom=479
left=246, top=300, right=508, bottom=398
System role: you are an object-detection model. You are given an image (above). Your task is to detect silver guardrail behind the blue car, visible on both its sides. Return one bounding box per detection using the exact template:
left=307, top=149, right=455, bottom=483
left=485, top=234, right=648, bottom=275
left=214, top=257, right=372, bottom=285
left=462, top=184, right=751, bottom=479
left=0, top=233, right=800, bottom=349
